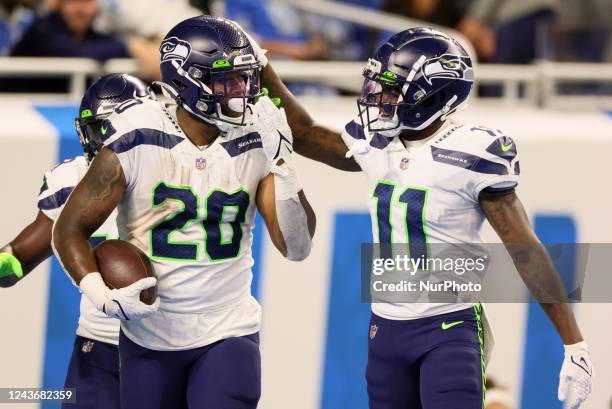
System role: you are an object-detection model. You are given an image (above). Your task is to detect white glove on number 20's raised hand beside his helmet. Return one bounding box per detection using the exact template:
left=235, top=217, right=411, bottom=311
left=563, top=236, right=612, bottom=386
left=253, top=96, right=293, bottom=163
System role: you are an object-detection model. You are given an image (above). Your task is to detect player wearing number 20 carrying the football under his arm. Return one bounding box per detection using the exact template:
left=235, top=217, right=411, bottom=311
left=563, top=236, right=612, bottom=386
left=54, top=16, right=315, bottom=409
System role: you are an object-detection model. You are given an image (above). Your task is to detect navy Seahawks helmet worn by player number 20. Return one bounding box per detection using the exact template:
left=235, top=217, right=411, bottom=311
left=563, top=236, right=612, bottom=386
left=159, top=15, right=262, bottom=131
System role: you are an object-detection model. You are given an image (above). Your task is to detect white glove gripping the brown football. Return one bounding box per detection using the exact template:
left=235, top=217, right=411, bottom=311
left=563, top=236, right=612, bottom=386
left=79, top=273, right=159, bottom=320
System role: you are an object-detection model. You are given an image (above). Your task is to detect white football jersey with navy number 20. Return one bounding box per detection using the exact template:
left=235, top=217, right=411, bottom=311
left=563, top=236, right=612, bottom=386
left=103, top=100, right=270, bottom=350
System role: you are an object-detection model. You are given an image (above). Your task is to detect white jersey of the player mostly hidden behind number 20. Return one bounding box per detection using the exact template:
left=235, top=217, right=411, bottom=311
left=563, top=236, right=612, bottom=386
left=38, top=156, right=119, bottom=345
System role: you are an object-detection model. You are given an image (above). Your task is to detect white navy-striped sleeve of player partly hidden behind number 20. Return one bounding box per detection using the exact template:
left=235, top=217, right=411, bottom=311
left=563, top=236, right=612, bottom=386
left=38, top=156, right=87, bottom=223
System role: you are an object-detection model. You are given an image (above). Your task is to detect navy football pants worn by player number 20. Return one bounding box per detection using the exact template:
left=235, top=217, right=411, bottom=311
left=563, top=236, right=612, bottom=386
left=119, top=332, right=261, bottom=409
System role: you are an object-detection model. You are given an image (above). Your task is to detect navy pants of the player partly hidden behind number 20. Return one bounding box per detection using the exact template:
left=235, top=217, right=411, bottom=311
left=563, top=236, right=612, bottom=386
left=62, top=336, right=120, bottom=409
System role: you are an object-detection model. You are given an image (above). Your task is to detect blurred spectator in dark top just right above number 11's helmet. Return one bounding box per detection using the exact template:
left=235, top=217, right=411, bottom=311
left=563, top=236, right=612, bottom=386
left=464, top=0, right=560, bottom=64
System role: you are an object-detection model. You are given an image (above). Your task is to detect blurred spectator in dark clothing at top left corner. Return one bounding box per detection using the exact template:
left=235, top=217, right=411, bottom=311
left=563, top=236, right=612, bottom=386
left=11, top=0, right=129, bottom=61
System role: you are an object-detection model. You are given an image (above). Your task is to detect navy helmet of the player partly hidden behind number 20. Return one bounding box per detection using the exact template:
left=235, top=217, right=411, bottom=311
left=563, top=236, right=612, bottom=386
left=75, top=74, right=156, bottom=161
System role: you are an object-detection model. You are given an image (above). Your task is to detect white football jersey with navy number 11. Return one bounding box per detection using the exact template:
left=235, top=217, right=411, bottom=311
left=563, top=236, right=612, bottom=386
left=342, top=121, right=520, bottom=320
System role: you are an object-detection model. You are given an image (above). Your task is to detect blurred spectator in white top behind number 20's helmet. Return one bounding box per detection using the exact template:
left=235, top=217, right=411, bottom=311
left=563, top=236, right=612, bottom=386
left=96, top=0, right=202, bottom=81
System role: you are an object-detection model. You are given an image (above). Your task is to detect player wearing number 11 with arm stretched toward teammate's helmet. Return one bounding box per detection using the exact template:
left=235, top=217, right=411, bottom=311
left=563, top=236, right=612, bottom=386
left=256, top=28, right=593, bottom=409
